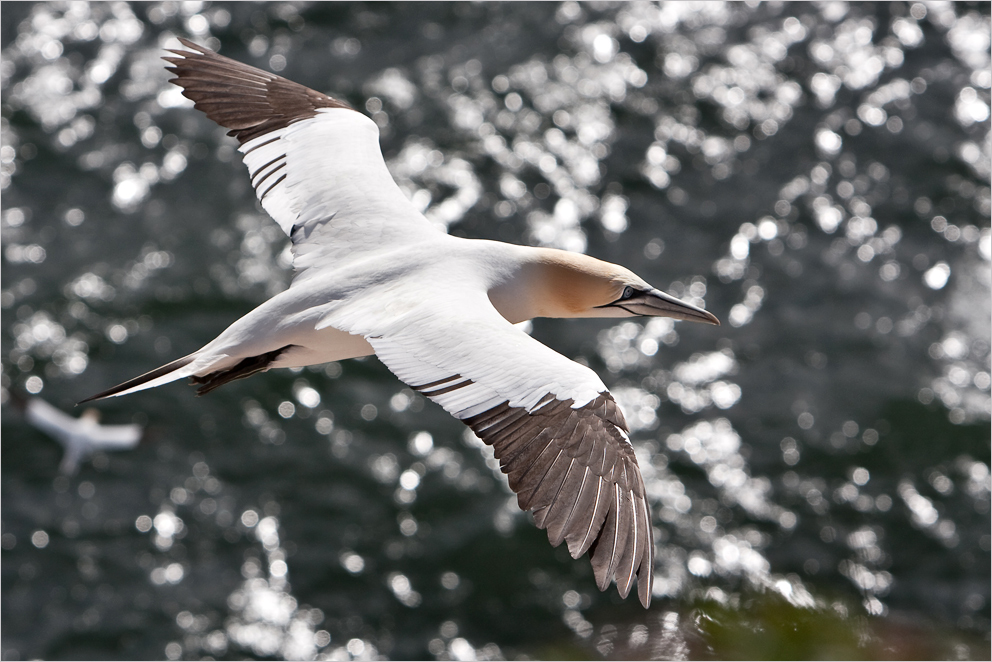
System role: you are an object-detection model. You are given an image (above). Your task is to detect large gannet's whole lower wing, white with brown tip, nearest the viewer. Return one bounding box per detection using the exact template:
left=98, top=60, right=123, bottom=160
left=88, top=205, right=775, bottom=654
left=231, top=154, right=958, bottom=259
left=335, top=291, right=654, bottom=606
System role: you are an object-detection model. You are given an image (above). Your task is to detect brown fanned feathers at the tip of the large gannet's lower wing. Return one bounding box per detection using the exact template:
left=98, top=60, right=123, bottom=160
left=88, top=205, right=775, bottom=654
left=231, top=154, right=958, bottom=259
left=464, top=393, right=654, bottom=606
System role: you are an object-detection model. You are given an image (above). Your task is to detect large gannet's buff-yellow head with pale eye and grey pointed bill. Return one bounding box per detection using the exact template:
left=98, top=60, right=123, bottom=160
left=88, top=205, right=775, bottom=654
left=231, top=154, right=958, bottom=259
left=536, top=249, right=720, bottom=325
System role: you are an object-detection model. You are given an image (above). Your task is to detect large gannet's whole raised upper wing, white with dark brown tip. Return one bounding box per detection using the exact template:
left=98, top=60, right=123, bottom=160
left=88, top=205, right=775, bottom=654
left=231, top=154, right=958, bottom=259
left=164, top=39, right=440, bottom=280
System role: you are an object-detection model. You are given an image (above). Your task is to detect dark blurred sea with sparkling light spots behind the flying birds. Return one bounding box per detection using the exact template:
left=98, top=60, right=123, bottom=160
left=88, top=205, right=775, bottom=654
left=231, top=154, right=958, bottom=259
left=0, top=2, right=992, bottom=660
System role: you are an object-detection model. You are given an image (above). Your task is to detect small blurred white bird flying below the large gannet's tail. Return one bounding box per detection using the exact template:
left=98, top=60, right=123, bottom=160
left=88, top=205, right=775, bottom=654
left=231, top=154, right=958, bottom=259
left=24, top=398, right=144, bottom=475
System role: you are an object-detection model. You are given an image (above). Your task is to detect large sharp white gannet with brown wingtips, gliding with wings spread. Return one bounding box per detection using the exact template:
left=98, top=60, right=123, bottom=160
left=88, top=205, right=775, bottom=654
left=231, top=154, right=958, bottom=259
left=84, top=39, right=719, bottom=606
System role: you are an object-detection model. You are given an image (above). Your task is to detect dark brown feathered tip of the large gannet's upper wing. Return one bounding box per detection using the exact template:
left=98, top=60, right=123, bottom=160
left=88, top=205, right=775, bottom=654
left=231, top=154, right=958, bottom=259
left=162, top=37, right=351, bottom=145
